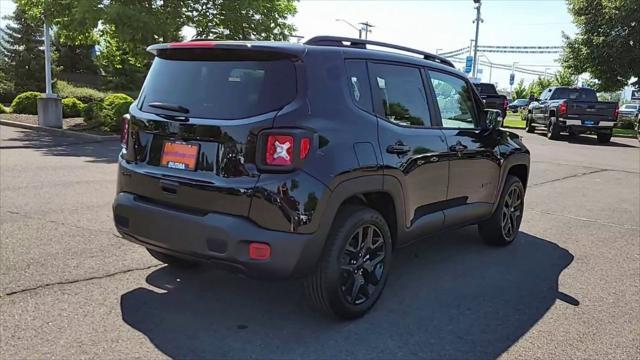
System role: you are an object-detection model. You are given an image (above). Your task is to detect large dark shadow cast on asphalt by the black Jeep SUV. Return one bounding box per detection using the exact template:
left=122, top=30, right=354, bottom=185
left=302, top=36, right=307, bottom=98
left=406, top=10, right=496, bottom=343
left=121, top=227, right=579, bottom=359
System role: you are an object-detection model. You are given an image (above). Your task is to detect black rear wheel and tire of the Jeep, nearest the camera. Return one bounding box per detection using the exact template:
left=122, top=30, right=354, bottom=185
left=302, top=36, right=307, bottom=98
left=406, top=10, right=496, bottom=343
left=305, top=205, right=392, bottom=319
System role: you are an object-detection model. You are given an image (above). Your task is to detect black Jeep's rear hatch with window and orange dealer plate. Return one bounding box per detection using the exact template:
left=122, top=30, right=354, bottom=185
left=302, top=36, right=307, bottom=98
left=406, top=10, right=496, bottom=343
left=119, top=42, right=300, bottom=215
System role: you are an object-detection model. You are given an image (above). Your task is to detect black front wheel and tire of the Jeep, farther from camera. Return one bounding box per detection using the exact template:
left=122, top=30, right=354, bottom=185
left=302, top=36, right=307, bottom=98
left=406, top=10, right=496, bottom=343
left=478, top=175, right=525, bottom=246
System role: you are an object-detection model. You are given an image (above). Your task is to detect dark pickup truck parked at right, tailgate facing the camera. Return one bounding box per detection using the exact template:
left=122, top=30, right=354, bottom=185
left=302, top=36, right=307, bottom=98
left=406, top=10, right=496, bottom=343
left=526, top=87, right=618, bottom=143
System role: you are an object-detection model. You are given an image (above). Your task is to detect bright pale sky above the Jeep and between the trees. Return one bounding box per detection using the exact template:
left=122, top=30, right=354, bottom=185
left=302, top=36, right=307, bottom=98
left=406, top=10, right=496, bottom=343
left=0, top=0, right=576, bottom=88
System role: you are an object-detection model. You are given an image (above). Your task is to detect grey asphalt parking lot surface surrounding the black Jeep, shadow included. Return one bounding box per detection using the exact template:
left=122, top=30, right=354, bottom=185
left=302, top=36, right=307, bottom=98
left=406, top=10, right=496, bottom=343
left=0, top=126, right=640, bottom=359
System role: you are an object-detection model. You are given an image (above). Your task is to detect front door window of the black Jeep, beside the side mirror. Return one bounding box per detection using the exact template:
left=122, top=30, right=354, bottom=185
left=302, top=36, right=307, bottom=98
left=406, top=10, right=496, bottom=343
left=429, top=71, right=477, bottom=128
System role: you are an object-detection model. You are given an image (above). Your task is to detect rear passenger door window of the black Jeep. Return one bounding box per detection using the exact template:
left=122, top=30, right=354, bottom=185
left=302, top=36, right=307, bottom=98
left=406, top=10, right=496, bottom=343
left=369, top=63, right=431, bottom=126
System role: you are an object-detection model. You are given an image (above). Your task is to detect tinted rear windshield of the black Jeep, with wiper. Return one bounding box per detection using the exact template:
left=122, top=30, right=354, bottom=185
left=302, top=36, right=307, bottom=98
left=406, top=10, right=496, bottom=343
left=139, top=58, right=296, bottom=119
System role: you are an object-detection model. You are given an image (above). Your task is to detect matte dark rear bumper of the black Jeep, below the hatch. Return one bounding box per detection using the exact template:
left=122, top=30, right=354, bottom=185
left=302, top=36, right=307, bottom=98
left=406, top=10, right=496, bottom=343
left=113, top=192, right=322, bottom=279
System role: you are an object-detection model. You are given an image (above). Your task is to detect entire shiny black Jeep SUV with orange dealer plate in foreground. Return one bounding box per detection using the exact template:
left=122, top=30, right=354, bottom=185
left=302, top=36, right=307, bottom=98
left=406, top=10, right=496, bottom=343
left=113, top=37, right=529, bottom=318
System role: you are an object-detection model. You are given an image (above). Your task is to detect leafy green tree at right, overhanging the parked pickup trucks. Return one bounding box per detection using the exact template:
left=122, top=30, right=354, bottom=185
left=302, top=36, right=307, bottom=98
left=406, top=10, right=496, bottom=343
left=561, top=0, right=640, bottom=91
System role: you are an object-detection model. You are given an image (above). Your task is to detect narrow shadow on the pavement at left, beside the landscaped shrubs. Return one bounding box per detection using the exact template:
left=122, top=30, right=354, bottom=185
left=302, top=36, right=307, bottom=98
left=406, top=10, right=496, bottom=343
left=0, top=130, right=121, bottom=163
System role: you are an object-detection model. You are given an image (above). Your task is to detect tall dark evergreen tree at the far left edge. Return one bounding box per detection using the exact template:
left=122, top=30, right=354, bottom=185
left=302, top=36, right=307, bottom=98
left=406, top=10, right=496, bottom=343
left=0, top=6, right=45, bottom=93
